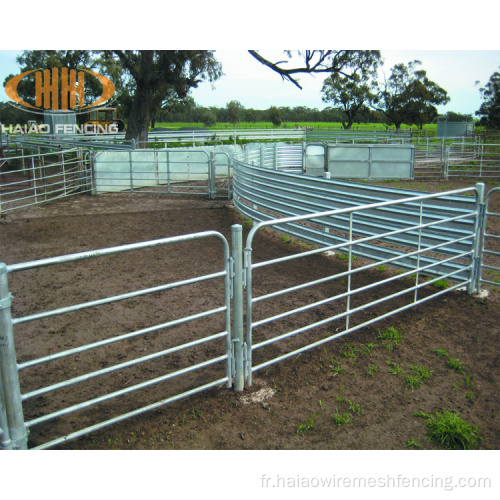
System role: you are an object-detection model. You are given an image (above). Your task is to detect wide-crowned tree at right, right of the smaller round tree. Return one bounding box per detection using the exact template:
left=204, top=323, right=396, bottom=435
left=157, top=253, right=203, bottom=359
left=374, top=60, right=450, bottom=130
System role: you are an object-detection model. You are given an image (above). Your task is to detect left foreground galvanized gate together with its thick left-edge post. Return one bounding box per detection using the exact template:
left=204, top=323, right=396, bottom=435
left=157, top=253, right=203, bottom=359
left=0, top=231, right=234, bottom=449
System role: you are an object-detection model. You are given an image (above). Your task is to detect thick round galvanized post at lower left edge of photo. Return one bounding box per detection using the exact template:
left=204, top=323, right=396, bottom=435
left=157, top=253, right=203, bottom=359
left=0, top=263, right=28, bottom=450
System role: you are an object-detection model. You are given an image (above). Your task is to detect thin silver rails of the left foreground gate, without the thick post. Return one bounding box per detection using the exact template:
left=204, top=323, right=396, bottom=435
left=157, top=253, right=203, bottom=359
left=0, top=231, right=233, bottom=449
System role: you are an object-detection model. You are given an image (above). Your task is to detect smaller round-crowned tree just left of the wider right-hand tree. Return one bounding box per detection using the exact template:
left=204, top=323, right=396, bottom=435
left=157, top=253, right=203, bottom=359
left=321, top=73, right=375, bottom=130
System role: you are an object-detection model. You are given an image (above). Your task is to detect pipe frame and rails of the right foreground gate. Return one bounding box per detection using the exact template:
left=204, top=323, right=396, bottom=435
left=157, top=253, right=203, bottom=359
left=242, top=180, right=484, bottom=385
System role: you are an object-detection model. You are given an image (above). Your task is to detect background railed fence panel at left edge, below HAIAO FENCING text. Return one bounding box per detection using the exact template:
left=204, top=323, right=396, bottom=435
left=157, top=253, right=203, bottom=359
left=0, top=149, right=92, bottom=214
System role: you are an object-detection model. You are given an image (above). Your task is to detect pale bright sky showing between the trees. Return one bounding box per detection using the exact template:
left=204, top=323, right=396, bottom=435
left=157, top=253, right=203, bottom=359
left=0, top=49, right=500, bottom=114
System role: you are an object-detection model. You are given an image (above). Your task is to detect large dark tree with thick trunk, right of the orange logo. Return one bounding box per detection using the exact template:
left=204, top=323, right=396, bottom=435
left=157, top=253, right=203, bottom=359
left=113, top=50, right=222, bottom=143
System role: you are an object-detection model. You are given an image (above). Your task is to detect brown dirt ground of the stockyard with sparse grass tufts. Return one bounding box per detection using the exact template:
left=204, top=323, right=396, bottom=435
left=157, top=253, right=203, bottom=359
left=0, top=181, right=500, bottom=450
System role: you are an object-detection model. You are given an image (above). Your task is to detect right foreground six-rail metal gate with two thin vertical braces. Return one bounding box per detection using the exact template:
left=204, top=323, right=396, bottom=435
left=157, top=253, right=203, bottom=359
left=235, top=182, right=484, bottom=384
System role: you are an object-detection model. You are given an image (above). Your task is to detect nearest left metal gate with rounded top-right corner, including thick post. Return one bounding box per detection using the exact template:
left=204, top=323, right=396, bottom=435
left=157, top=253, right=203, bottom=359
left=0, top=231, right=235, bottom=449
